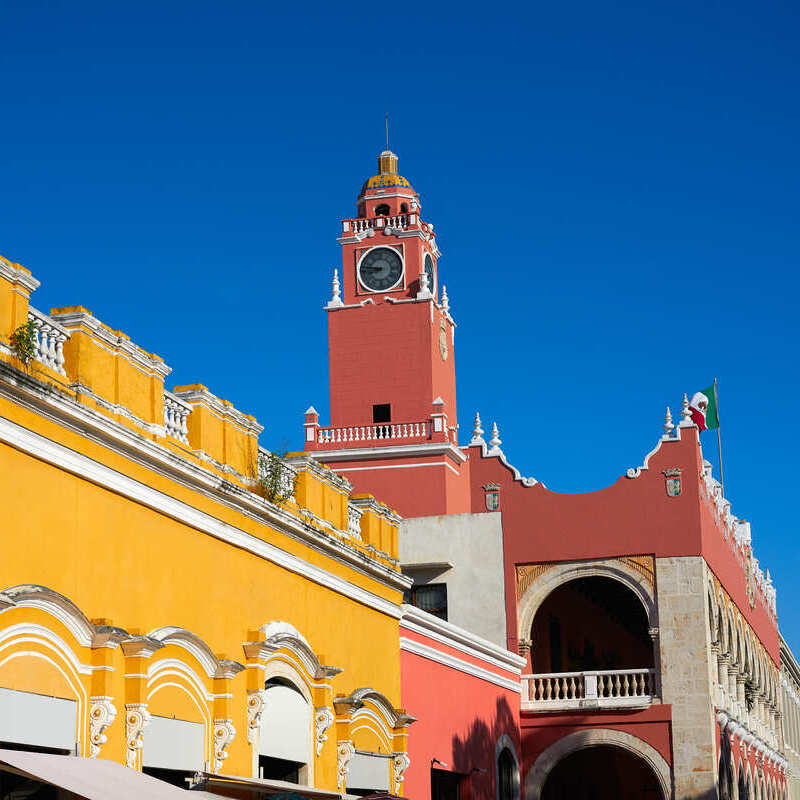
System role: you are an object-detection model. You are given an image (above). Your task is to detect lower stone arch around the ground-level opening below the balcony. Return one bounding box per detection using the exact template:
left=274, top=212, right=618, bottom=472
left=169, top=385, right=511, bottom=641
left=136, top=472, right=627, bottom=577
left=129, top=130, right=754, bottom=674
left=525, top=728, right=672, bottom=800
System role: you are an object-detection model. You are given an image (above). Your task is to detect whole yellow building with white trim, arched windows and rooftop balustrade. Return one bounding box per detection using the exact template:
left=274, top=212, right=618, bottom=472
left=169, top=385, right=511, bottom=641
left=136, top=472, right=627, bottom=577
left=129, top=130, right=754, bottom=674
left=0, top=258, right=413, bottom=794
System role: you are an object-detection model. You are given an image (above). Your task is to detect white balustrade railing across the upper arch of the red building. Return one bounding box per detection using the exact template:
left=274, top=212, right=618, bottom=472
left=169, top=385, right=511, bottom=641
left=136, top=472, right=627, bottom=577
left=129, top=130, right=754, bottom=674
left=522, top=669, right=655, bottom=711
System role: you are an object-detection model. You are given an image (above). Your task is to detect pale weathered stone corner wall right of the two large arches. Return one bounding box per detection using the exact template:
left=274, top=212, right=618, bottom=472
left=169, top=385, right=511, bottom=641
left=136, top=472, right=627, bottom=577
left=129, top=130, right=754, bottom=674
left=656, top=556, right=717, bottom=800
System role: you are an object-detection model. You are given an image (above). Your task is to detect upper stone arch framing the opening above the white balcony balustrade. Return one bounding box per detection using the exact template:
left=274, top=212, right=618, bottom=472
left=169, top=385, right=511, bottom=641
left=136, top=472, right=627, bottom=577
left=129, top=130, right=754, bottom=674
left=517, top=558, right=658, bottom=638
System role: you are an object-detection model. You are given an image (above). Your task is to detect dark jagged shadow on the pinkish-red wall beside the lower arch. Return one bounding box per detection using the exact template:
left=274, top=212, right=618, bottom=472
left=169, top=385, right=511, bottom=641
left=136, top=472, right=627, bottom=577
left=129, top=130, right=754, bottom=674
left=450, top=697, right=519, bottom=800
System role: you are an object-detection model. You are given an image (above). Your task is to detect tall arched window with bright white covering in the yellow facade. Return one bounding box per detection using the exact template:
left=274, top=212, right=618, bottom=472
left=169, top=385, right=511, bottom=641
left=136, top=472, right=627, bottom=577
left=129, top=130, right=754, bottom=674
left=258, top=678, right=312, bottom=783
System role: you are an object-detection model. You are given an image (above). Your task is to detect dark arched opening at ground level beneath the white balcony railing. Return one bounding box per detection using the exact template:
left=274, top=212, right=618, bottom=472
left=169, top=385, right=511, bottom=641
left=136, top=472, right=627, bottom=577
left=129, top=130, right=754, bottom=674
left=541, top=745, right=664, bottom=800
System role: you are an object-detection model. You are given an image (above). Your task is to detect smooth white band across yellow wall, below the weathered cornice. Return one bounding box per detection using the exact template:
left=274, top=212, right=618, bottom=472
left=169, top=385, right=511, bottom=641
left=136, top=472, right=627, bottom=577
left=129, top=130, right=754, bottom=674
left=0, top=417, right=407, bottom=619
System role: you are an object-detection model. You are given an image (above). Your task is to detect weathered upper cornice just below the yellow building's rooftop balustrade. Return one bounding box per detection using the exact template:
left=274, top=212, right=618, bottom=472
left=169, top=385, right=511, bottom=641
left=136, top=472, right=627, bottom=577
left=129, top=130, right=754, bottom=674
left=0, top=363, right=409, bottom=596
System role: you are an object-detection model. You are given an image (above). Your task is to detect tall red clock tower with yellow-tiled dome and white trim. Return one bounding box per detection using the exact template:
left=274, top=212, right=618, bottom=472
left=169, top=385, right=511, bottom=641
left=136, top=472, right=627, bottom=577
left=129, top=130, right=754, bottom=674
left=305, top=150, right=469, bottom=516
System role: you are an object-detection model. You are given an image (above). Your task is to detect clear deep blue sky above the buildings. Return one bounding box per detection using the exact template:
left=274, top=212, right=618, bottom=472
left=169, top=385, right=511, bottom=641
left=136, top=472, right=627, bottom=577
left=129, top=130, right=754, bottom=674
left=0, top=0, right=800, bottom=647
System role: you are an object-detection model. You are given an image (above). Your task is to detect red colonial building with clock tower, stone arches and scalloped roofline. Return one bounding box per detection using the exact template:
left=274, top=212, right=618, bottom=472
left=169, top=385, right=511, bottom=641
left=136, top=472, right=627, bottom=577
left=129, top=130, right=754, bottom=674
left=304, top=151, right=797, bottom=800
